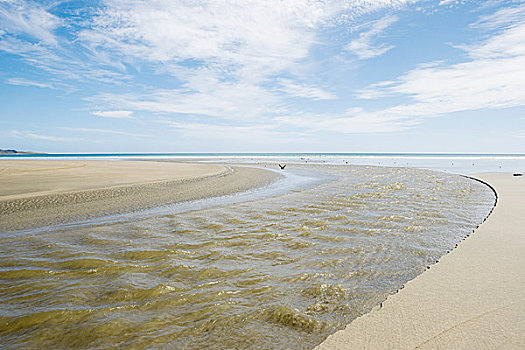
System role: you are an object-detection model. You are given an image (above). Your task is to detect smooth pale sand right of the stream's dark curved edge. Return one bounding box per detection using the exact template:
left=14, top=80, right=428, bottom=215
left=316, top=173, right=525, bottom=350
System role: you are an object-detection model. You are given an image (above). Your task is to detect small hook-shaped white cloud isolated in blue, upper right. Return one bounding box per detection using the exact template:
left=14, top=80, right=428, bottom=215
left=346, top=16, right=398, bottom=59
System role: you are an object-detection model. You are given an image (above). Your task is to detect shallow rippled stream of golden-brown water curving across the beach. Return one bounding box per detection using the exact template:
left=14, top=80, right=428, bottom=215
left=0, top=166, right=494, bottom=349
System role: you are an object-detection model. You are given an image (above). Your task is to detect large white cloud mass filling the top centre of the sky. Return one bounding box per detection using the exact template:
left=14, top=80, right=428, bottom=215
left=79, top=0, right=417, bottom=120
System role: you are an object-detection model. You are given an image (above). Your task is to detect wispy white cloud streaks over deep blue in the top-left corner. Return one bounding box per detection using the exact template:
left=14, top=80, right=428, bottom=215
left=0, top=0, right=127, bottom=92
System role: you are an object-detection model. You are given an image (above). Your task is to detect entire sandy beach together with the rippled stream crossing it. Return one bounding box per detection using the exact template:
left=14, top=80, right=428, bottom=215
left=0, top=159, right=525, bottom=350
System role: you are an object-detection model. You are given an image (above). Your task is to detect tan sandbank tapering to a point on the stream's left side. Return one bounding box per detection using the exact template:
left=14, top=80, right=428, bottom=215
left=0, top=160, right=279, bottom=232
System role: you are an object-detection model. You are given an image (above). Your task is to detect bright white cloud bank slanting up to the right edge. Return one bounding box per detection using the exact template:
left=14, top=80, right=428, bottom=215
left=352, top=5, right=525, bottom=123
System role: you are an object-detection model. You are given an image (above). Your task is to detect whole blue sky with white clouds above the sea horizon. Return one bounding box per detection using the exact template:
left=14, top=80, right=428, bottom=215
left=0, top=0, right=525, bottom=153
